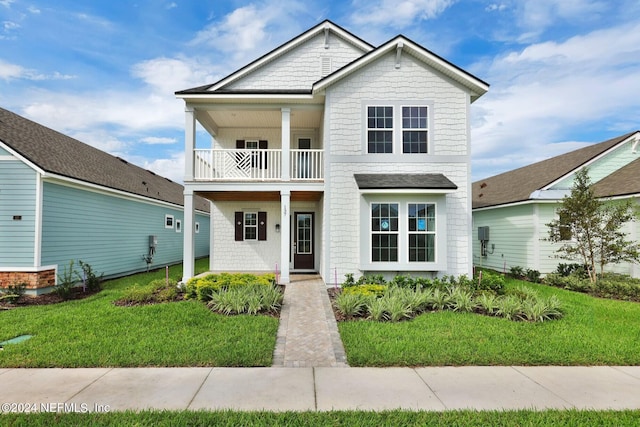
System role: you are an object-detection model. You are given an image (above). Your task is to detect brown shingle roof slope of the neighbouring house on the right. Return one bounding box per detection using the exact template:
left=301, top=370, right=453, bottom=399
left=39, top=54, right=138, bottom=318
left=472, top=131, right=637, bottom=209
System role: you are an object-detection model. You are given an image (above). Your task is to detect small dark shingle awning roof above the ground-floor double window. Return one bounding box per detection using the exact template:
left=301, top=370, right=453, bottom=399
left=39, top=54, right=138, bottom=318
left=353, top=173, right=458, bottom=190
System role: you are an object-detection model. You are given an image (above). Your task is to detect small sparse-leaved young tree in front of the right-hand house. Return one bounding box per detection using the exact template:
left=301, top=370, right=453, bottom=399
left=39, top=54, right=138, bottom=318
left=547, top=168, right=640, bottom=283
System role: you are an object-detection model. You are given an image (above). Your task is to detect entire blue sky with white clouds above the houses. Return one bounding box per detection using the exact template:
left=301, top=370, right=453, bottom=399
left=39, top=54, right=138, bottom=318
left=0, top=0, right=640, bottom=182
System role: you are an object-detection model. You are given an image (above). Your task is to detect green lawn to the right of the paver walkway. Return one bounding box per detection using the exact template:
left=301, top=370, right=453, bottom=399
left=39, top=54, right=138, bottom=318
left=338, top=280, right=640, bottom=366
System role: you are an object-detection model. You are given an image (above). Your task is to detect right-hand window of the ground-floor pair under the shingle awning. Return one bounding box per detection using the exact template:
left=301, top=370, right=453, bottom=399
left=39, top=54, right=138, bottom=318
left=407, top=203, right=436, bottom=262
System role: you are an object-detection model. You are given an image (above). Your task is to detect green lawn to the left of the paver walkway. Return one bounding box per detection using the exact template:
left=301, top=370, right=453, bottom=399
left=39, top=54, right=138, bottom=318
left=0, top=259, right=278, bottom=368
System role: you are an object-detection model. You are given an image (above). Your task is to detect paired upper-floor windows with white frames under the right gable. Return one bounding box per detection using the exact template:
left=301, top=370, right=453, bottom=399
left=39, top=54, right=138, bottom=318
left=366, top=103, right=429, bottom=154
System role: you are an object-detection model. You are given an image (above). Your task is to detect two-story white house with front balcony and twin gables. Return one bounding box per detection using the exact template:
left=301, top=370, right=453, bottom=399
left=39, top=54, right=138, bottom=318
left=176, top=21, right=488, bottom=283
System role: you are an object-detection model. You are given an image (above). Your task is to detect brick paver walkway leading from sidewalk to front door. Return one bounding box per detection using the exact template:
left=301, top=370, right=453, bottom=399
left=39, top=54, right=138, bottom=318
left=273, top=276, right=348, bottom=368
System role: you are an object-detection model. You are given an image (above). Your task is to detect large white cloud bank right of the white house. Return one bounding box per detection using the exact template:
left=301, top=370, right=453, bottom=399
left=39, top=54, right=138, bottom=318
left=472, top=23, right=640, bottom=178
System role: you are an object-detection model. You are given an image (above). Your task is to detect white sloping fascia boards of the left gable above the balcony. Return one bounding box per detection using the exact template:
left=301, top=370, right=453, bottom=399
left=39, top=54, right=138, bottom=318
left=209, top=22, right=372, bottom=91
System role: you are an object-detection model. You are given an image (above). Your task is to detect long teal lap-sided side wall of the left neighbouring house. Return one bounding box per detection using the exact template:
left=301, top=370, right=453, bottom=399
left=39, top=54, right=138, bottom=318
left=42, top=183, right=209, bottom=276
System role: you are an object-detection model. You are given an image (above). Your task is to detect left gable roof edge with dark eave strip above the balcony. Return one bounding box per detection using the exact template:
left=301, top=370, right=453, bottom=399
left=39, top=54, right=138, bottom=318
left=175, top=19, right=373, bottom=95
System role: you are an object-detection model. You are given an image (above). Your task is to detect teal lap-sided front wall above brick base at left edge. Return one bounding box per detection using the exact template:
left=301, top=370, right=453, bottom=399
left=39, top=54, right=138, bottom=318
left=0, top=161, right=37, bottom=267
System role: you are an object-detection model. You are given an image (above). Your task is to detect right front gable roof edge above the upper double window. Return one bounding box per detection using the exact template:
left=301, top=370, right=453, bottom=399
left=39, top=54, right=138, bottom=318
left=313, top=35, right=489, bottom=102
